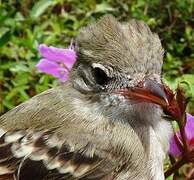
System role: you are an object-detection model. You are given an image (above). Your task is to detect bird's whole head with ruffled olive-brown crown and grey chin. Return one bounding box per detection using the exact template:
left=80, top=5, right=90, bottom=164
left=71, top=16, right=167, bottom=124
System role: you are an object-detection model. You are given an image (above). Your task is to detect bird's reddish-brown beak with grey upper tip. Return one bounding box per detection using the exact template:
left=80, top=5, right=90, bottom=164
left=119, top=79, right=169, bottom=108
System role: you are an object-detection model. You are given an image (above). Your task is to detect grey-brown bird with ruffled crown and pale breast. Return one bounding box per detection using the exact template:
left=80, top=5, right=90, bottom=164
left=0, top=15, right=172, bottom=180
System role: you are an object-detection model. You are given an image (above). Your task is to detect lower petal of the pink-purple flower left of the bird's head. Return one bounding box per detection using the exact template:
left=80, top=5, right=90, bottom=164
left=36, top=59, right=68, bottom=80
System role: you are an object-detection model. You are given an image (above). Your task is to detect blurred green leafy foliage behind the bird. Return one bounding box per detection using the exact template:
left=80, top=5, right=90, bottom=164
left=0, top=0, right=194, bottom=114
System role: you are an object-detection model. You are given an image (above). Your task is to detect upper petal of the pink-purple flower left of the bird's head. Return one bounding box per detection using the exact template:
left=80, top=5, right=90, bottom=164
left=39, top=44, right=76, bottom=70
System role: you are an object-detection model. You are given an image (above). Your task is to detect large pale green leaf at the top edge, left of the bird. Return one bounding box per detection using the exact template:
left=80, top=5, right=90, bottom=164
left=30, top=0, right=53, bottom=19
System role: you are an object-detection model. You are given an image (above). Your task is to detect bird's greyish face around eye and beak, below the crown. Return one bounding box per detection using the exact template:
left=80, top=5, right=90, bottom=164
left=73, top=60, right=165, bottom=124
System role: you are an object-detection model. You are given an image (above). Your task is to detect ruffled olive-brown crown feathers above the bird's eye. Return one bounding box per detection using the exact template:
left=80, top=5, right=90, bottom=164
left=77, top=15, right=164, bottom=74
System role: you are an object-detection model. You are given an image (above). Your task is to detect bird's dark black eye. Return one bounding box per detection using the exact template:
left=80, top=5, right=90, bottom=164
left=93, top=67, right=109, bottom=85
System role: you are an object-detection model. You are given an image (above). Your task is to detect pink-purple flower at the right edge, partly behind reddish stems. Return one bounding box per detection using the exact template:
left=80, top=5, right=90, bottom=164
left=169, top=114, right=194, bottom=157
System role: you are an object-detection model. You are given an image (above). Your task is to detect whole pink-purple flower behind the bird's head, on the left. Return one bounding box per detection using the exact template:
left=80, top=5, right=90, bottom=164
left=36, top=44, right=77, bottom=82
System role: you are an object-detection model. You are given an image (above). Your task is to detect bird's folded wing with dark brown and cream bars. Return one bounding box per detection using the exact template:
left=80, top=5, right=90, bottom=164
left=0, top=130, right=114, bottom=180
